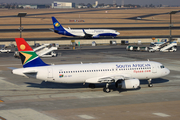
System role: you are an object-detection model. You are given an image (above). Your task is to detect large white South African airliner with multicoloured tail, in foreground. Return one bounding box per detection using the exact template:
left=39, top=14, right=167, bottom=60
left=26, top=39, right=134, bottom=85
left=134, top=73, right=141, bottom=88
left=12, top=38, right=170, bottom=93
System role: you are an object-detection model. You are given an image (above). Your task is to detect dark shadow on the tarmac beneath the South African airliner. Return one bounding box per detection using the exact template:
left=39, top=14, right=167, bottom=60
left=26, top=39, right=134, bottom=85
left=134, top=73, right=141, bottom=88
left=25, top=78, right=169, bottom=92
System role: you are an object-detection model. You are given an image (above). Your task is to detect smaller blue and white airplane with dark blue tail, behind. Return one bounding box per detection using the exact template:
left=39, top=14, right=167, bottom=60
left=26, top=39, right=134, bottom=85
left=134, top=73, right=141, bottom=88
left=52, top=17, right=120, bottom=38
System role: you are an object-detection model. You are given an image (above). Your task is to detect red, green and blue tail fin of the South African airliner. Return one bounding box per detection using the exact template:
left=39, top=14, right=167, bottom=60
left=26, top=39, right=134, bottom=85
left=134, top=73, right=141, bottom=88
left=15, top=38, right=48, bottom=68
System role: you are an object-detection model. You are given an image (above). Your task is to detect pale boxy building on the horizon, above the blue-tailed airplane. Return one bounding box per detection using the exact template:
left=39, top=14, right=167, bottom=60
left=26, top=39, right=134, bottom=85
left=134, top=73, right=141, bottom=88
left=52, top=1, right=75, bottom=8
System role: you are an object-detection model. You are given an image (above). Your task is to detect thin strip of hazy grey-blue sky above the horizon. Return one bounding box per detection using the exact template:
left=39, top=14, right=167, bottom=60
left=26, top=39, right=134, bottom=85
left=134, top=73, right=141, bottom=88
left=0, top=0, right=180, bottom=5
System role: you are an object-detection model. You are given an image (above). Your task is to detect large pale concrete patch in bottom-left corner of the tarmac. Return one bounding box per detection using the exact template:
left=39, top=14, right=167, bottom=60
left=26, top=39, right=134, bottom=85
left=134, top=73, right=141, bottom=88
left=0, top=108, right=55, bottom=120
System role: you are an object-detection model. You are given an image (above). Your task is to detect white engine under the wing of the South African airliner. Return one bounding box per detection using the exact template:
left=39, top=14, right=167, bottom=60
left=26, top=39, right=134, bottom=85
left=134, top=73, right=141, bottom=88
left=116, top=79, right=140, bottom=89
